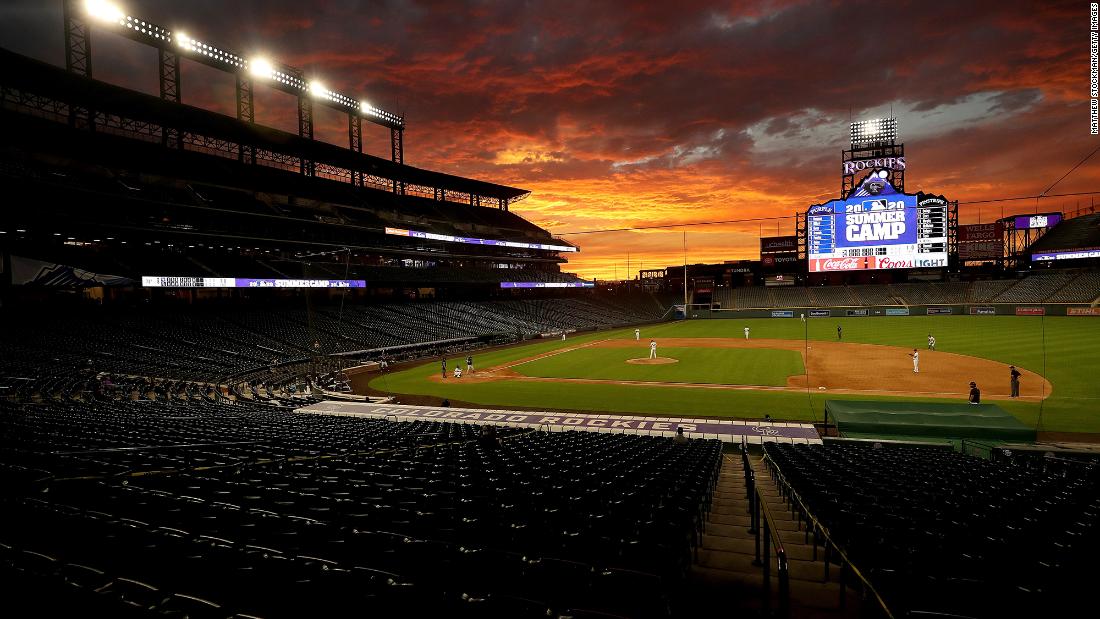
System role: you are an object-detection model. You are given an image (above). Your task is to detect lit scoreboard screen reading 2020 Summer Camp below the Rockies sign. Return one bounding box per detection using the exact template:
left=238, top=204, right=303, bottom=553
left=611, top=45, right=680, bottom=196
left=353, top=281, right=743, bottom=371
left=806, top=179, right=947, bottom=273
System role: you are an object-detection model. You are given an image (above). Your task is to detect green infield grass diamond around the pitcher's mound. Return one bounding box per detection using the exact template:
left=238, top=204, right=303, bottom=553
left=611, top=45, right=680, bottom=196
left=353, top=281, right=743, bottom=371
left=512, top=342, right=805, bottom=387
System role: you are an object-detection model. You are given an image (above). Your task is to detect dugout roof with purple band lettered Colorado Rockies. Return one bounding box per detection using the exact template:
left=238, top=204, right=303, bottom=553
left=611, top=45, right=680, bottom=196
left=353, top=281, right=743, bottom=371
left=297, top=400, right=822, bottom=444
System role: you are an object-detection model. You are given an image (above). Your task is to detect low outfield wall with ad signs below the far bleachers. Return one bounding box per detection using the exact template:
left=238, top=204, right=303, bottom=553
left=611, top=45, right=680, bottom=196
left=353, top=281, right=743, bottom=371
left=692, top=303, right=1100, bottom=319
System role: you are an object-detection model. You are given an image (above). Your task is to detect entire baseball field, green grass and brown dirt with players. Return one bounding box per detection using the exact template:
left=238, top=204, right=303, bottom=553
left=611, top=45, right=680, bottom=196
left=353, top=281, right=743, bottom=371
left=369, top=316, right=1100, bottom=433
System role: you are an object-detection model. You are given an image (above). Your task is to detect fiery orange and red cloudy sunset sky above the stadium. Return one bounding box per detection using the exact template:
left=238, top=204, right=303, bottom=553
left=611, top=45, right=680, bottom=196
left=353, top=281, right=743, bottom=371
left=0, top=0, right=1100, bottom=278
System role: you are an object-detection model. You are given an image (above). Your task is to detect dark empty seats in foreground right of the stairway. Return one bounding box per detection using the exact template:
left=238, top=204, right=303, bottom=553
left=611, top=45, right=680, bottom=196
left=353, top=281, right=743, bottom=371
left=765, top=443, right=1100, bottom=617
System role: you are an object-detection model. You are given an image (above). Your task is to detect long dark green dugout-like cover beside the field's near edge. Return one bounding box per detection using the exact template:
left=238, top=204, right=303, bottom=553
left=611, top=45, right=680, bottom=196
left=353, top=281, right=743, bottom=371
left=825, top=400, right=1035, bottom=442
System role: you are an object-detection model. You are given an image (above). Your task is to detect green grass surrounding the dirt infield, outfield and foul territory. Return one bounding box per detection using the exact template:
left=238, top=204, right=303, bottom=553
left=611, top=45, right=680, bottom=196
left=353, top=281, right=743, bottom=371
left=371, top=316, right=1100, bottom=432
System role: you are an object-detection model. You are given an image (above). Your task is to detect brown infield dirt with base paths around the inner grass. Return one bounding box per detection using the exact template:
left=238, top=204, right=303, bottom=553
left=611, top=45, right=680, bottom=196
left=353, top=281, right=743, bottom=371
left=428, top=338, right=1054, bottom=401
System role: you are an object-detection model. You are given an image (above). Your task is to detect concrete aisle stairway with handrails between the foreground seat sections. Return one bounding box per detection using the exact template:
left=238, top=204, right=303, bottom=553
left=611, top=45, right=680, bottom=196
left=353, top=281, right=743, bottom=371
left=675, top=453, right=860, bottom=618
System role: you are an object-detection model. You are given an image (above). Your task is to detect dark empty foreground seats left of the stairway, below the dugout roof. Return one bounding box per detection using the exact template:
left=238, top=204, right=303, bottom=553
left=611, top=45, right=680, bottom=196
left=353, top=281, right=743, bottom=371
left=0, top=401, right=722, bottom=619
